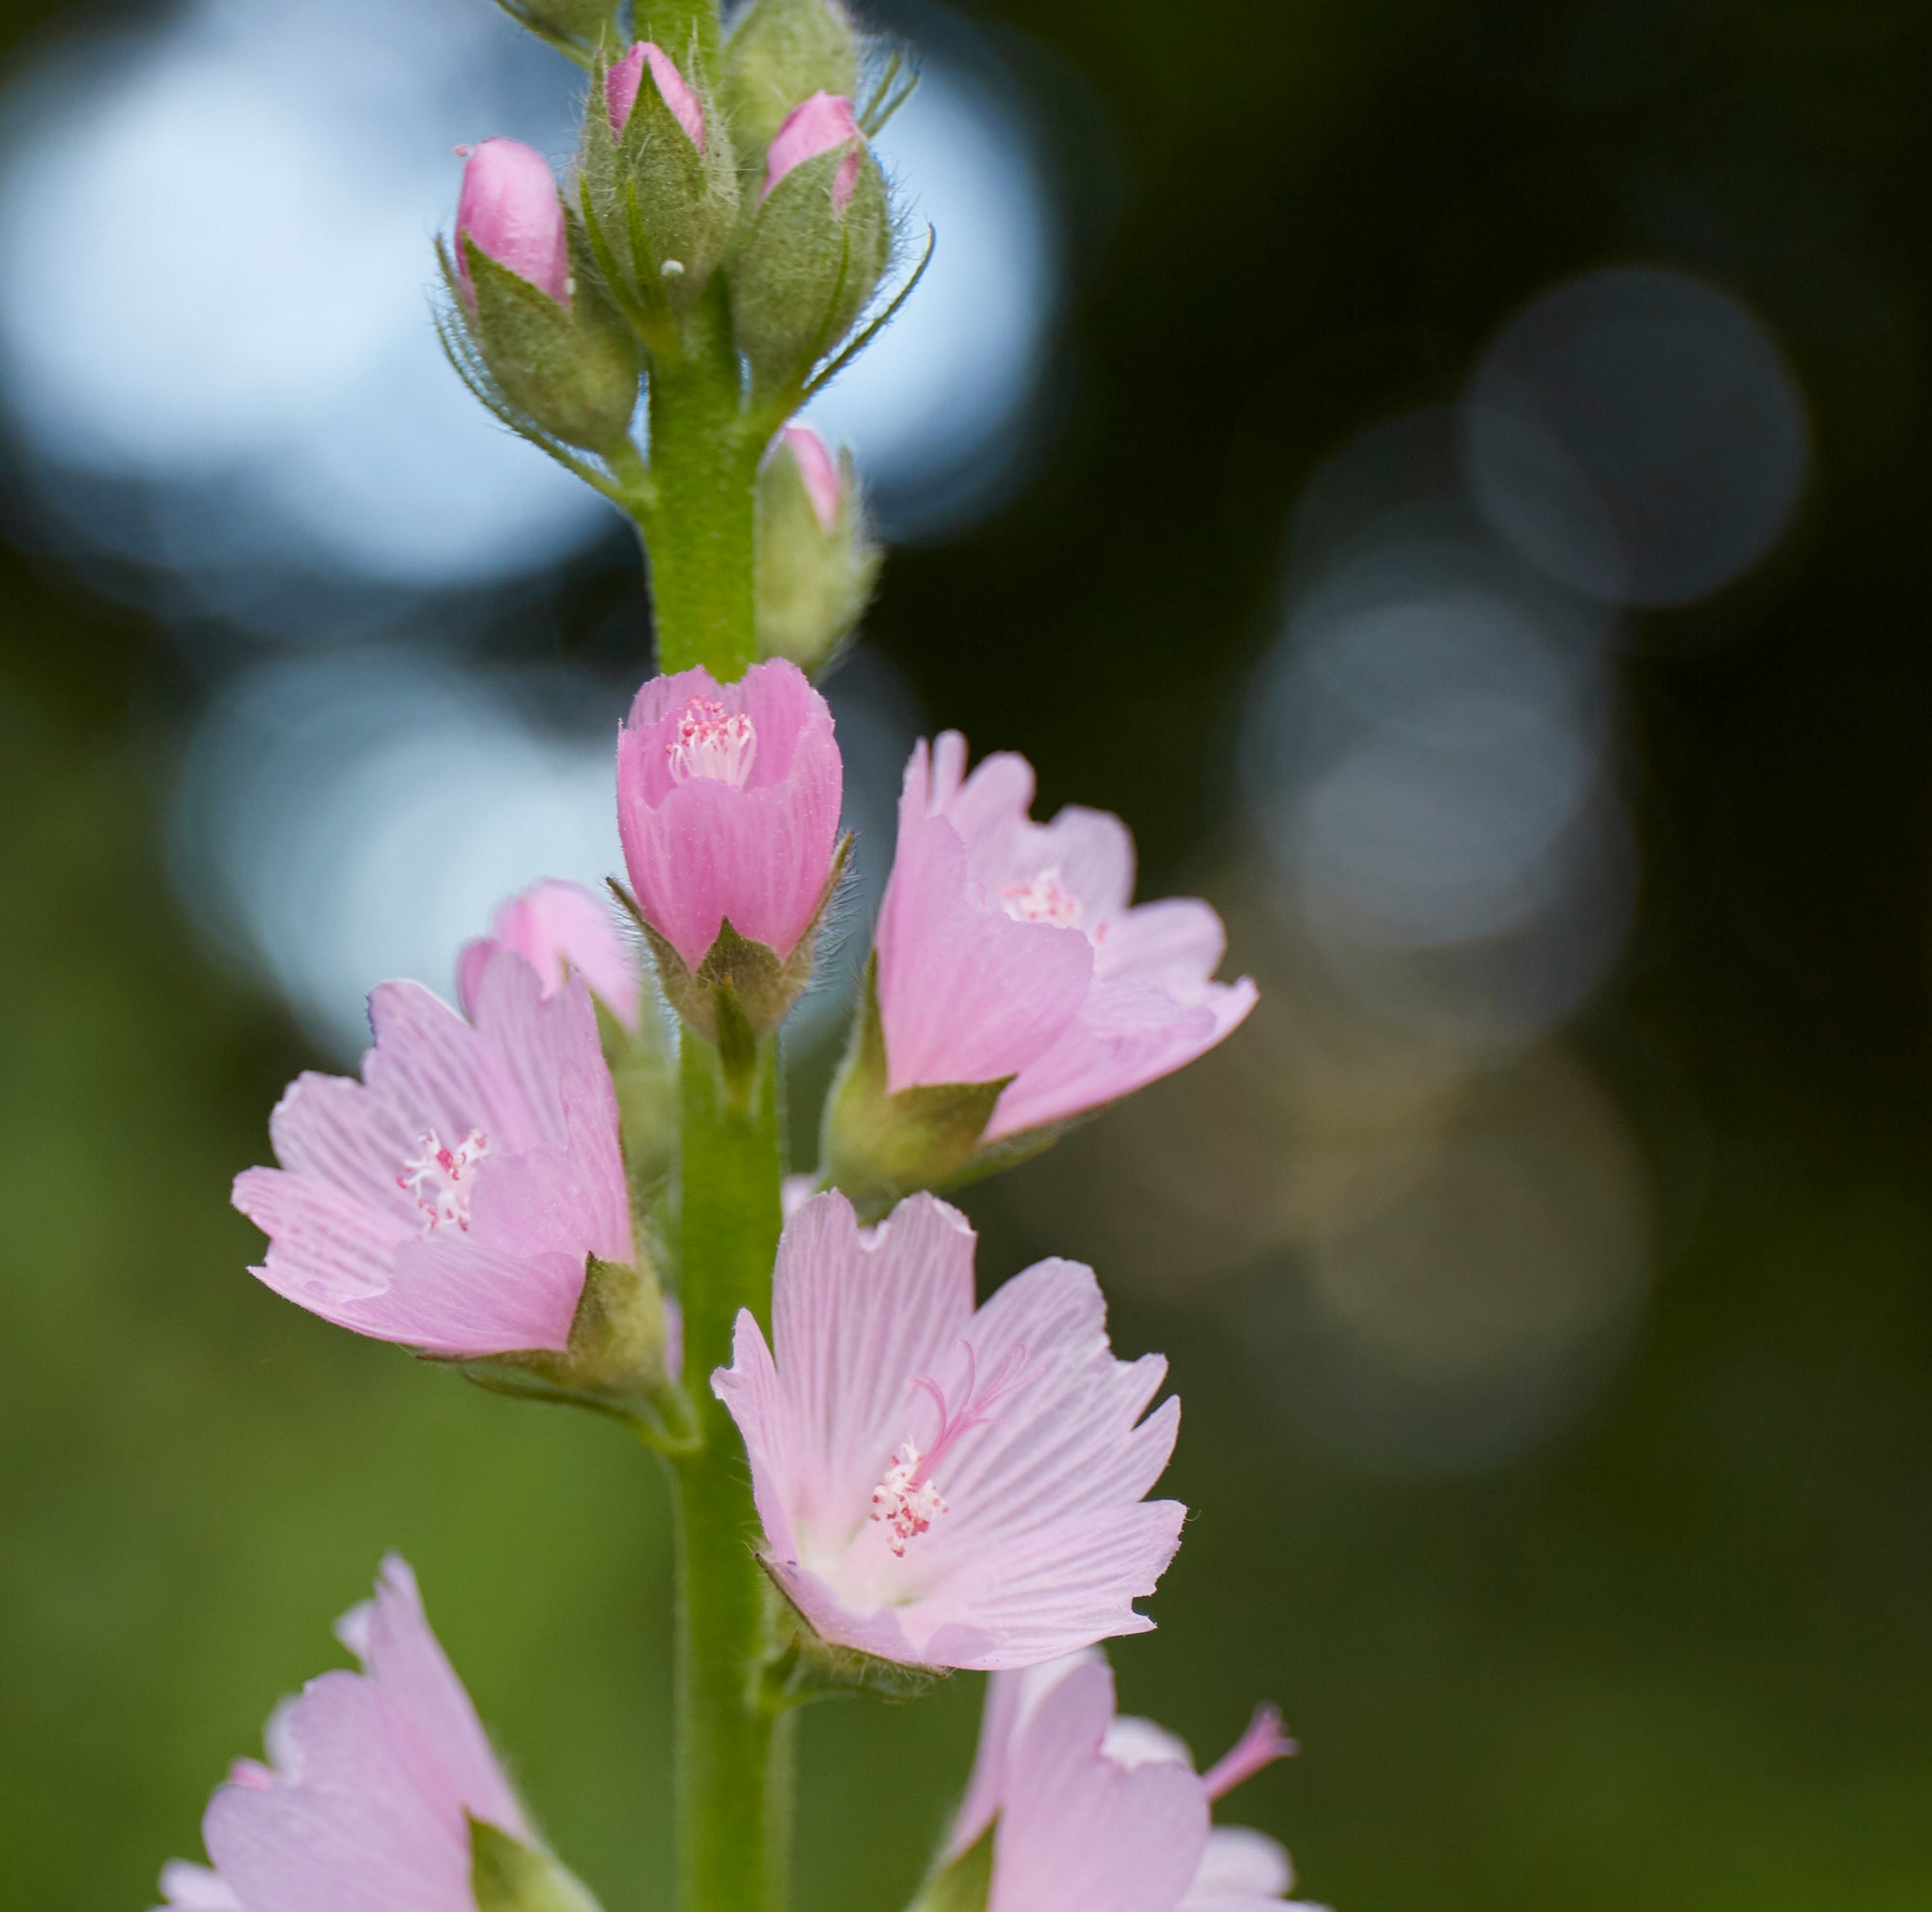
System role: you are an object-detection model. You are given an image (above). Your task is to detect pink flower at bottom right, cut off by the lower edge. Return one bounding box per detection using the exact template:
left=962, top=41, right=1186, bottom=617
left=947, top=1653, right=1294, bottom=1912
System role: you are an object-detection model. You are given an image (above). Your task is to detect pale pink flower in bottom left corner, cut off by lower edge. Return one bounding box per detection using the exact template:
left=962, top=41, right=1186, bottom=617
left=160, top=1555, right=531, bottom=1912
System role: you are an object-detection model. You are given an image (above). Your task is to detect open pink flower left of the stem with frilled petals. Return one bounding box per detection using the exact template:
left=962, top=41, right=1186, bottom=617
left=234, top=947, right=632, bottom=1357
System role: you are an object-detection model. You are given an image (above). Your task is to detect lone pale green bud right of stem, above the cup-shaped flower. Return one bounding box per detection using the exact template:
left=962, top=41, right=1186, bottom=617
left=757, top=425, right=879, bottom=671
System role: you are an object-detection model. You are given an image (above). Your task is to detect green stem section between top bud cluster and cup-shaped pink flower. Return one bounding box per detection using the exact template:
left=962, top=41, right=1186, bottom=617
left=649, top=274, right=769, bottom=678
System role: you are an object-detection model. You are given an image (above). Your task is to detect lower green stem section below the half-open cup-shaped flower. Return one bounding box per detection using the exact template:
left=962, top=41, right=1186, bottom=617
left=672, top=1031, right=792, bottom=1912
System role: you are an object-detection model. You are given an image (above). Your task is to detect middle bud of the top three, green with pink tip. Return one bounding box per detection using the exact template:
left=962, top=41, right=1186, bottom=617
left=582, top=41, right=738, bottom=313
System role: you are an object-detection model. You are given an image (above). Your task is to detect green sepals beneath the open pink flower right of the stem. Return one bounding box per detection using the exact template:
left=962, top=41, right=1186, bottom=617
left=821, top=953, right=1065, bottom=1220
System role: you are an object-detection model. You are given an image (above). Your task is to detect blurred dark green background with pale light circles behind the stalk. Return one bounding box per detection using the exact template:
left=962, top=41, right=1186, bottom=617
left=0, top=0, right=1932, bottom=1912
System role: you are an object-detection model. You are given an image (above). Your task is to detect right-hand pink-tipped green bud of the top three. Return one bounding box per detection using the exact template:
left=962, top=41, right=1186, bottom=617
left=732, top=93, right=891, bottom=390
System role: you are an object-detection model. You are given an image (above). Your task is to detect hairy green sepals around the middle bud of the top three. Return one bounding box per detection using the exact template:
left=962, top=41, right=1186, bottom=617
left=580, top=41, right=740, bottom=320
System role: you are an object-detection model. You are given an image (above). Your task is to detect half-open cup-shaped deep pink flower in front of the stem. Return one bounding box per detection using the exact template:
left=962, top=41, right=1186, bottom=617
left=616, top=659, right=844, bottom=969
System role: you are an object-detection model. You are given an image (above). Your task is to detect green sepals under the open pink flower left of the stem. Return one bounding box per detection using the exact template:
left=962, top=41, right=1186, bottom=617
left=440, top=1255, right=694, bottom=1448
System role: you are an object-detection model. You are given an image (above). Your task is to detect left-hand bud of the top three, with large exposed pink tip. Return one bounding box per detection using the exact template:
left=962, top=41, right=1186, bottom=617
left=448, top=139, right=638, bottom=452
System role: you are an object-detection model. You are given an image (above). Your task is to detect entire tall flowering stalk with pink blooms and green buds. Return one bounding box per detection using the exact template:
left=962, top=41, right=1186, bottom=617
left=162, top=0, right=1314, bottom=1912
